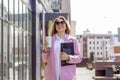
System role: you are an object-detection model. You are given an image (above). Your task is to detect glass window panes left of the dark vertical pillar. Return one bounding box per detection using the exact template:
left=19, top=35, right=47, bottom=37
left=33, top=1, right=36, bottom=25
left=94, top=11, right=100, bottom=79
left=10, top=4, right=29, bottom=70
left=0, top=0, right=32, bottom=80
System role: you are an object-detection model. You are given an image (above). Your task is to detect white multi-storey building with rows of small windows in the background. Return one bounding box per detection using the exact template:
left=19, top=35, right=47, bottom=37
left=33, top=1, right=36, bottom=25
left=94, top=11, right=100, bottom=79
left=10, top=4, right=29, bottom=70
left=77, top=30, right=118, bottom=60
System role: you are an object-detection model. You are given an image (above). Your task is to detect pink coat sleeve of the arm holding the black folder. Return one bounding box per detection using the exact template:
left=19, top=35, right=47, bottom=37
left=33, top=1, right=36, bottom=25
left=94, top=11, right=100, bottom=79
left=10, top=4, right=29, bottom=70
left=67, top=39, right=82, bottom=63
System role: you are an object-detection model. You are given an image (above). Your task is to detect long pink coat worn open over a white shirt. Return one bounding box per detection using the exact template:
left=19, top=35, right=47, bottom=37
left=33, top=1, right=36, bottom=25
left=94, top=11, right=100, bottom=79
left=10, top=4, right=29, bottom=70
left=42, top=35, right=82, bottom=80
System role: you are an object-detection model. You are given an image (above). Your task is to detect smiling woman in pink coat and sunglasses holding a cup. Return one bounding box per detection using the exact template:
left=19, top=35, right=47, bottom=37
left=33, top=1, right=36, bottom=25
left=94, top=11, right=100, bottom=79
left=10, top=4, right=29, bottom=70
left=42, top=16, right=82, bottom=80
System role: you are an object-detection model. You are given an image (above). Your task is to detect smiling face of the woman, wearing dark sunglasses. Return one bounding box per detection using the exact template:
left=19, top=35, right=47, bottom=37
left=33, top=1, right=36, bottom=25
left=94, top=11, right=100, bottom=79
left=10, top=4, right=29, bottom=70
left=55, top=19, right=66, bottom=33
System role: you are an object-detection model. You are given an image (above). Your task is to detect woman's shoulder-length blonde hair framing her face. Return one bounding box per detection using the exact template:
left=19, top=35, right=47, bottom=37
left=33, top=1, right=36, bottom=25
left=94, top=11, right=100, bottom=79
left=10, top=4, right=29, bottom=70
left=50, top=16, right=71, bottom=36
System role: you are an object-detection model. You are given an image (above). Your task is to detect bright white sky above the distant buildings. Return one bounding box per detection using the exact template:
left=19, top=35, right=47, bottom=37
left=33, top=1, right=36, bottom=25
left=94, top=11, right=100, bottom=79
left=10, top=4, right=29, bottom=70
left=71, top=0, right=120, bottom=35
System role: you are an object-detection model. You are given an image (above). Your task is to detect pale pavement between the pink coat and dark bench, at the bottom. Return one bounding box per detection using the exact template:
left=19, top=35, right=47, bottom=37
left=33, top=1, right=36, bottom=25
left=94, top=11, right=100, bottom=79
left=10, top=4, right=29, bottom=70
left=76, top=67, right=95, bottom=80
